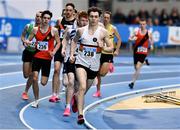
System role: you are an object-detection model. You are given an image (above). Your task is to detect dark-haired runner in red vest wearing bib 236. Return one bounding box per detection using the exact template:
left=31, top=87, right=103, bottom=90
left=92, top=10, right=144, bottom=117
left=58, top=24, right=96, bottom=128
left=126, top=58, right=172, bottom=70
left=26, top=10, right=60, bottom=108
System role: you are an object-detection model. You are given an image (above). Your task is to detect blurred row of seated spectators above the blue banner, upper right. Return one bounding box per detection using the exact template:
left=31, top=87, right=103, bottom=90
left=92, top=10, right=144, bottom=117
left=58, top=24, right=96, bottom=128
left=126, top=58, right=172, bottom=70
left=112, top=7, right=180, bottom=26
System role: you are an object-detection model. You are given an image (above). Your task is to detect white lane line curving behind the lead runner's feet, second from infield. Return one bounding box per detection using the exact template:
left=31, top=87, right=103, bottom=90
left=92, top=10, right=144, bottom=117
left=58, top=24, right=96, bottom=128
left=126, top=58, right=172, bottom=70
left=19, top=77, right=180, bottom=129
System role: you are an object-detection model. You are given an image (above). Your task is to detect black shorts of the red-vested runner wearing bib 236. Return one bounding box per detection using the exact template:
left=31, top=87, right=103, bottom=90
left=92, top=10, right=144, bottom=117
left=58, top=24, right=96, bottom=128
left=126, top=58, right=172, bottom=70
left=32, top=58, right=51, bottom=77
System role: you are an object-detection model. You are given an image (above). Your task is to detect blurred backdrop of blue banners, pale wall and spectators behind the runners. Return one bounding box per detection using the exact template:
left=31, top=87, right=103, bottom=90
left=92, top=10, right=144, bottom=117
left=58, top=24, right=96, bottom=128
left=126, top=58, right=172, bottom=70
left=0, top=0, right=180, bottom=55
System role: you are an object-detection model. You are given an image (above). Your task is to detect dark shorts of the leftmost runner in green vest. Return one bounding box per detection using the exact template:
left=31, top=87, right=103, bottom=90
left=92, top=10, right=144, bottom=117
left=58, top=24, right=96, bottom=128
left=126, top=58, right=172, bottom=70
left=22, top=49, right=35, bottom=62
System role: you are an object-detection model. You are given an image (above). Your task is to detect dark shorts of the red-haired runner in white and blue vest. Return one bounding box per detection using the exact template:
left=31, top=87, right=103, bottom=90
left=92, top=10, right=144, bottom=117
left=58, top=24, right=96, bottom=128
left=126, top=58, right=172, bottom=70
left=63, top=59, right=75, bottom=74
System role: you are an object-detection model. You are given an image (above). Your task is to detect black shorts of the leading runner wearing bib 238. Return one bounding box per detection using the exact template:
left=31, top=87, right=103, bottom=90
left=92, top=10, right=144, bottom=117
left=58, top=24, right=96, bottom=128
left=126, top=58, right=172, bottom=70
left=75, top=64, right=98, bottom=79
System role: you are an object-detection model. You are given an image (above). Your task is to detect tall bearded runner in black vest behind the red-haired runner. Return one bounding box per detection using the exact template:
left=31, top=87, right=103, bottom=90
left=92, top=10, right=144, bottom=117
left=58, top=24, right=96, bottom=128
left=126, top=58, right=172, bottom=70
left=49, top=3, right=76, bottom=103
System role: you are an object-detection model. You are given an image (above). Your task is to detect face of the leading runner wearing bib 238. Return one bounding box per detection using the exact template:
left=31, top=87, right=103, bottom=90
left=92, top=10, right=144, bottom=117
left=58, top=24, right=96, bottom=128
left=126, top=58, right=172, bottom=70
left=89, top=12, right=99, bottom=26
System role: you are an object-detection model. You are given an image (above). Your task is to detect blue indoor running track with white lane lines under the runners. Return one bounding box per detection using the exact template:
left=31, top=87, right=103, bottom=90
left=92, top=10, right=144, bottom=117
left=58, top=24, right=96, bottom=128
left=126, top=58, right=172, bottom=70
left=0, top=55, right=180, bottom=129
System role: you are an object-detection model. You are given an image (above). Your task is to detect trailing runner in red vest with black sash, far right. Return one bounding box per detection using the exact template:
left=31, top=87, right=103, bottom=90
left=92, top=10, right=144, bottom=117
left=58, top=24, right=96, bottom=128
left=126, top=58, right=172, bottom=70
left=129, top=18, right=153, bottom=89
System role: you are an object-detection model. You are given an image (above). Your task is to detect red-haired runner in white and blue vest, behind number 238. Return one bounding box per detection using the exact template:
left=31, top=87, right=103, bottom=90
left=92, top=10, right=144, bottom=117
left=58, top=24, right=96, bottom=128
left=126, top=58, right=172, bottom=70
left=62, top=11, right=88, bottom=116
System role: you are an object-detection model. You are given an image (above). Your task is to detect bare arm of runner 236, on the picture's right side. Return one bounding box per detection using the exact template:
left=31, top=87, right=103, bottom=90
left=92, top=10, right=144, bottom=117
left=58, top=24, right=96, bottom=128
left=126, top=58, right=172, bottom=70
left=50, top=27, right=61, bottom=57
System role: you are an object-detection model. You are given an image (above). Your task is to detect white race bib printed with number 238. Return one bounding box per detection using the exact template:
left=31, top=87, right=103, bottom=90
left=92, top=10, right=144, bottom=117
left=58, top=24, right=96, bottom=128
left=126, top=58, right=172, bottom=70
left=83, top=47, right=97, bottom=58
